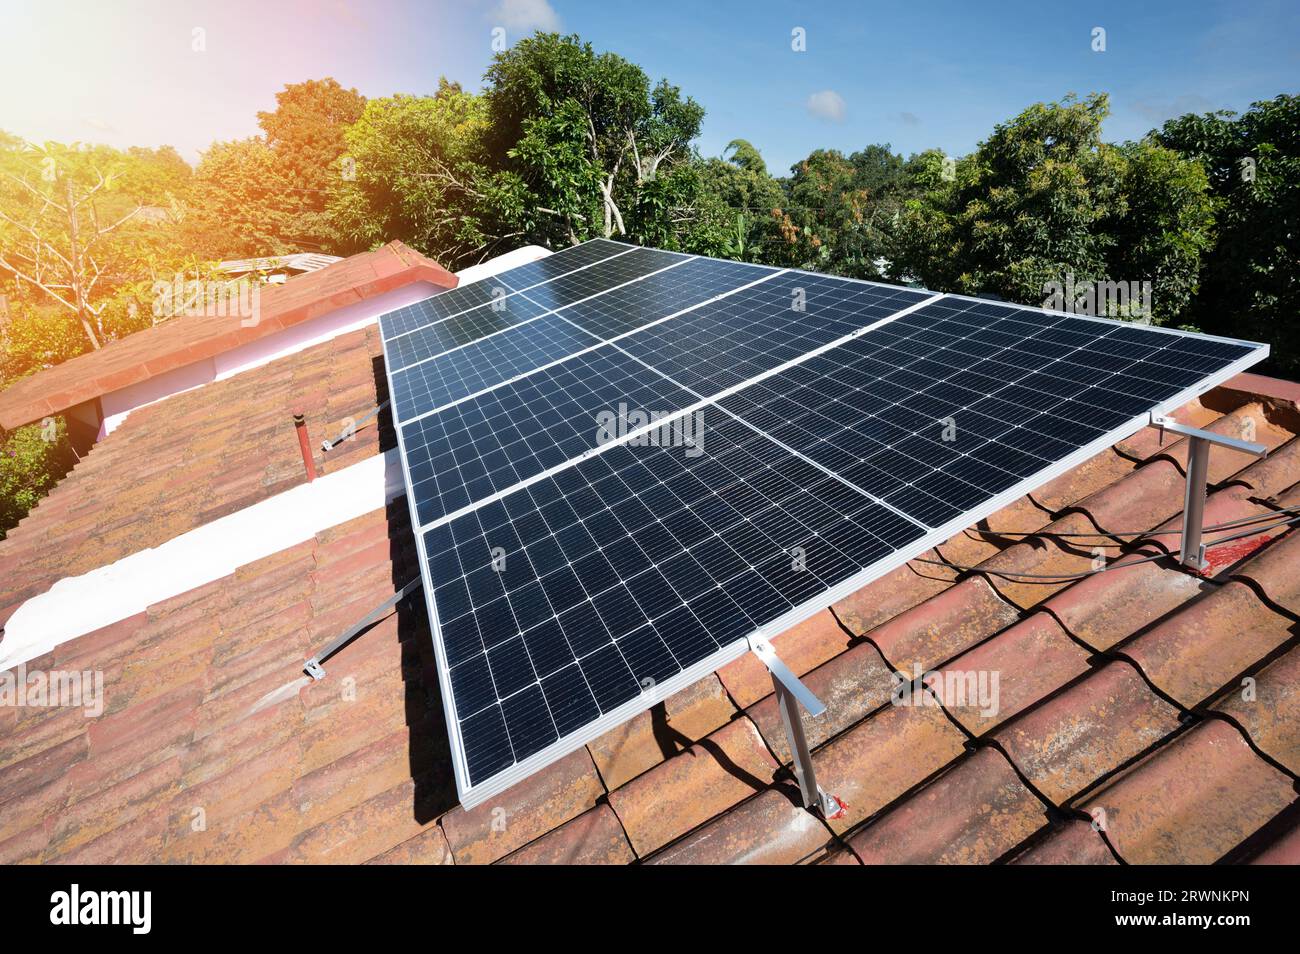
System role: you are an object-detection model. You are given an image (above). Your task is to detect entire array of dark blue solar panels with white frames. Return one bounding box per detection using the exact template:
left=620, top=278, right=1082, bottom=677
left=380, top=240, right=1268, bottom=806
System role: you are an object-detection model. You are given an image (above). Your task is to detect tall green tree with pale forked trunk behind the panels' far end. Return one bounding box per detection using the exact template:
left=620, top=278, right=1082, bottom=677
left=485, top=34, right=705, bottom=247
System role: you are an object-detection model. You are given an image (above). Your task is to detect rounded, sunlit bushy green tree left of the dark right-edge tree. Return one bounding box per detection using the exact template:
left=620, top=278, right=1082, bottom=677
left=891, top=95, right=1213, bottom=322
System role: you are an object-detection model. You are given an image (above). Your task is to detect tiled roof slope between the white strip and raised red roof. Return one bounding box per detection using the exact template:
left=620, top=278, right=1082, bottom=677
left=0, top=325, right=387, bottom=626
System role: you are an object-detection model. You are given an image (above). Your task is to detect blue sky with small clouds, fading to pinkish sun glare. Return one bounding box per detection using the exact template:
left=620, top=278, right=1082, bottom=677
left=0, top=0, right=1300, bottom=173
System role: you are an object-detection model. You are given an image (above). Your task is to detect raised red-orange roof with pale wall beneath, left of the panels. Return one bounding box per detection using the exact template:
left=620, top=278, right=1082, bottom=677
left=0, top=242, right=456, bottom=430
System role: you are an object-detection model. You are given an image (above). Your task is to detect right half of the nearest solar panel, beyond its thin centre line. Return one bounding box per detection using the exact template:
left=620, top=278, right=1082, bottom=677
left=722, top=299, right=1252, bottom=528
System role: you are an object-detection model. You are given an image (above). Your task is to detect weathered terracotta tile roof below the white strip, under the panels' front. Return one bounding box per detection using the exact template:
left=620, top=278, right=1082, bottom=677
left=0, top=363, right=1300, bottom=864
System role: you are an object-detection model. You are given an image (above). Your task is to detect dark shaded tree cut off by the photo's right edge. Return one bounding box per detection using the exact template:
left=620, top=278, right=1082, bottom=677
left=1154, top=95, right=1300, bottom=377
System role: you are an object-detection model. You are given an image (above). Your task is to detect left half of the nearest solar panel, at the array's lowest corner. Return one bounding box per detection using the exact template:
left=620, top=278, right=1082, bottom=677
left=424, top=407, right=923, bottom=784
